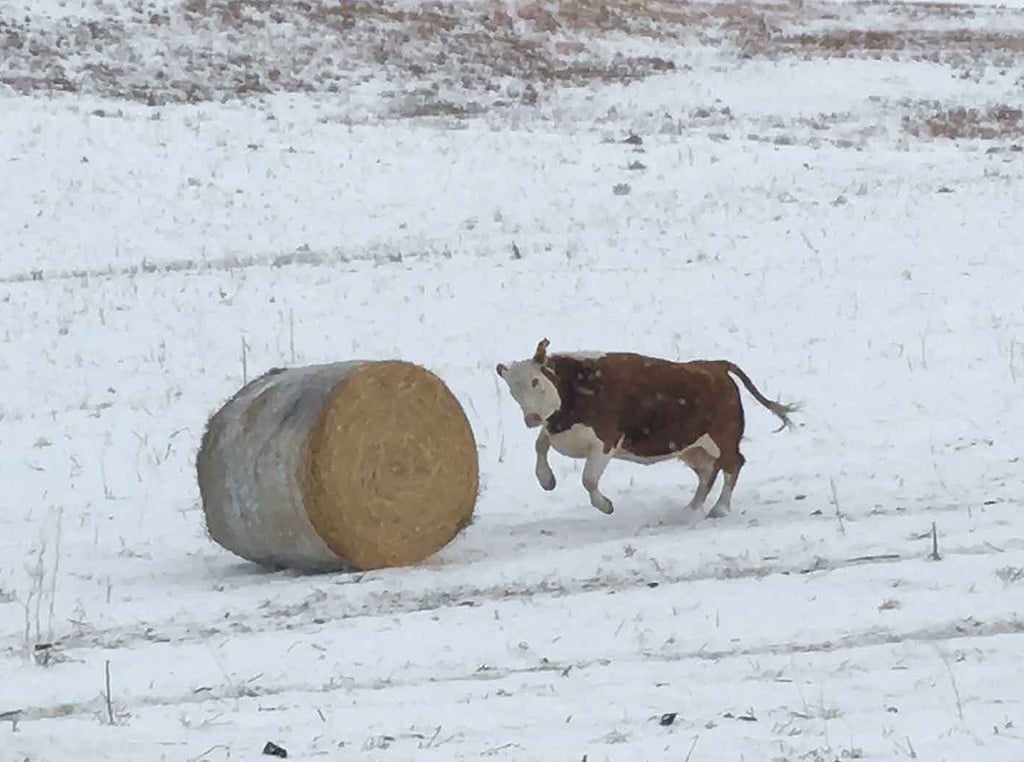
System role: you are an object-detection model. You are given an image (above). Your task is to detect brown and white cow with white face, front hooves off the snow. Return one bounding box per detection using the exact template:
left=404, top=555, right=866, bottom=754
left=497, top=339, right=799, bottom=517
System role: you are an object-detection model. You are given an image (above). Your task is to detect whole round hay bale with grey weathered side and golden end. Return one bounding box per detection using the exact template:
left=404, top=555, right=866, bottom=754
left=196, top=361, right=479, bottom=572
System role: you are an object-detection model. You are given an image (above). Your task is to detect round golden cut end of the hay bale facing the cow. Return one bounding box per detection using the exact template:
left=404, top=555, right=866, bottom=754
left=300, top=361, right=479, bottom=569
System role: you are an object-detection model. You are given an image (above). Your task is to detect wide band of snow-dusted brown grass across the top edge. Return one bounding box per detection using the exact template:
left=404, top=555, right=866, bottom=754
left=6, top=0, right=1024, bottom=113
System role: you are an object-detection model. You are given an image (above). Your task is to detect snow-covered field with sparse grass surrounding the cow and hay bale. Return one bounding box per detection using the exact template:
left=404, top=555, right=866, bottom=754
left=0, top=0, right=1024, bottom=762
